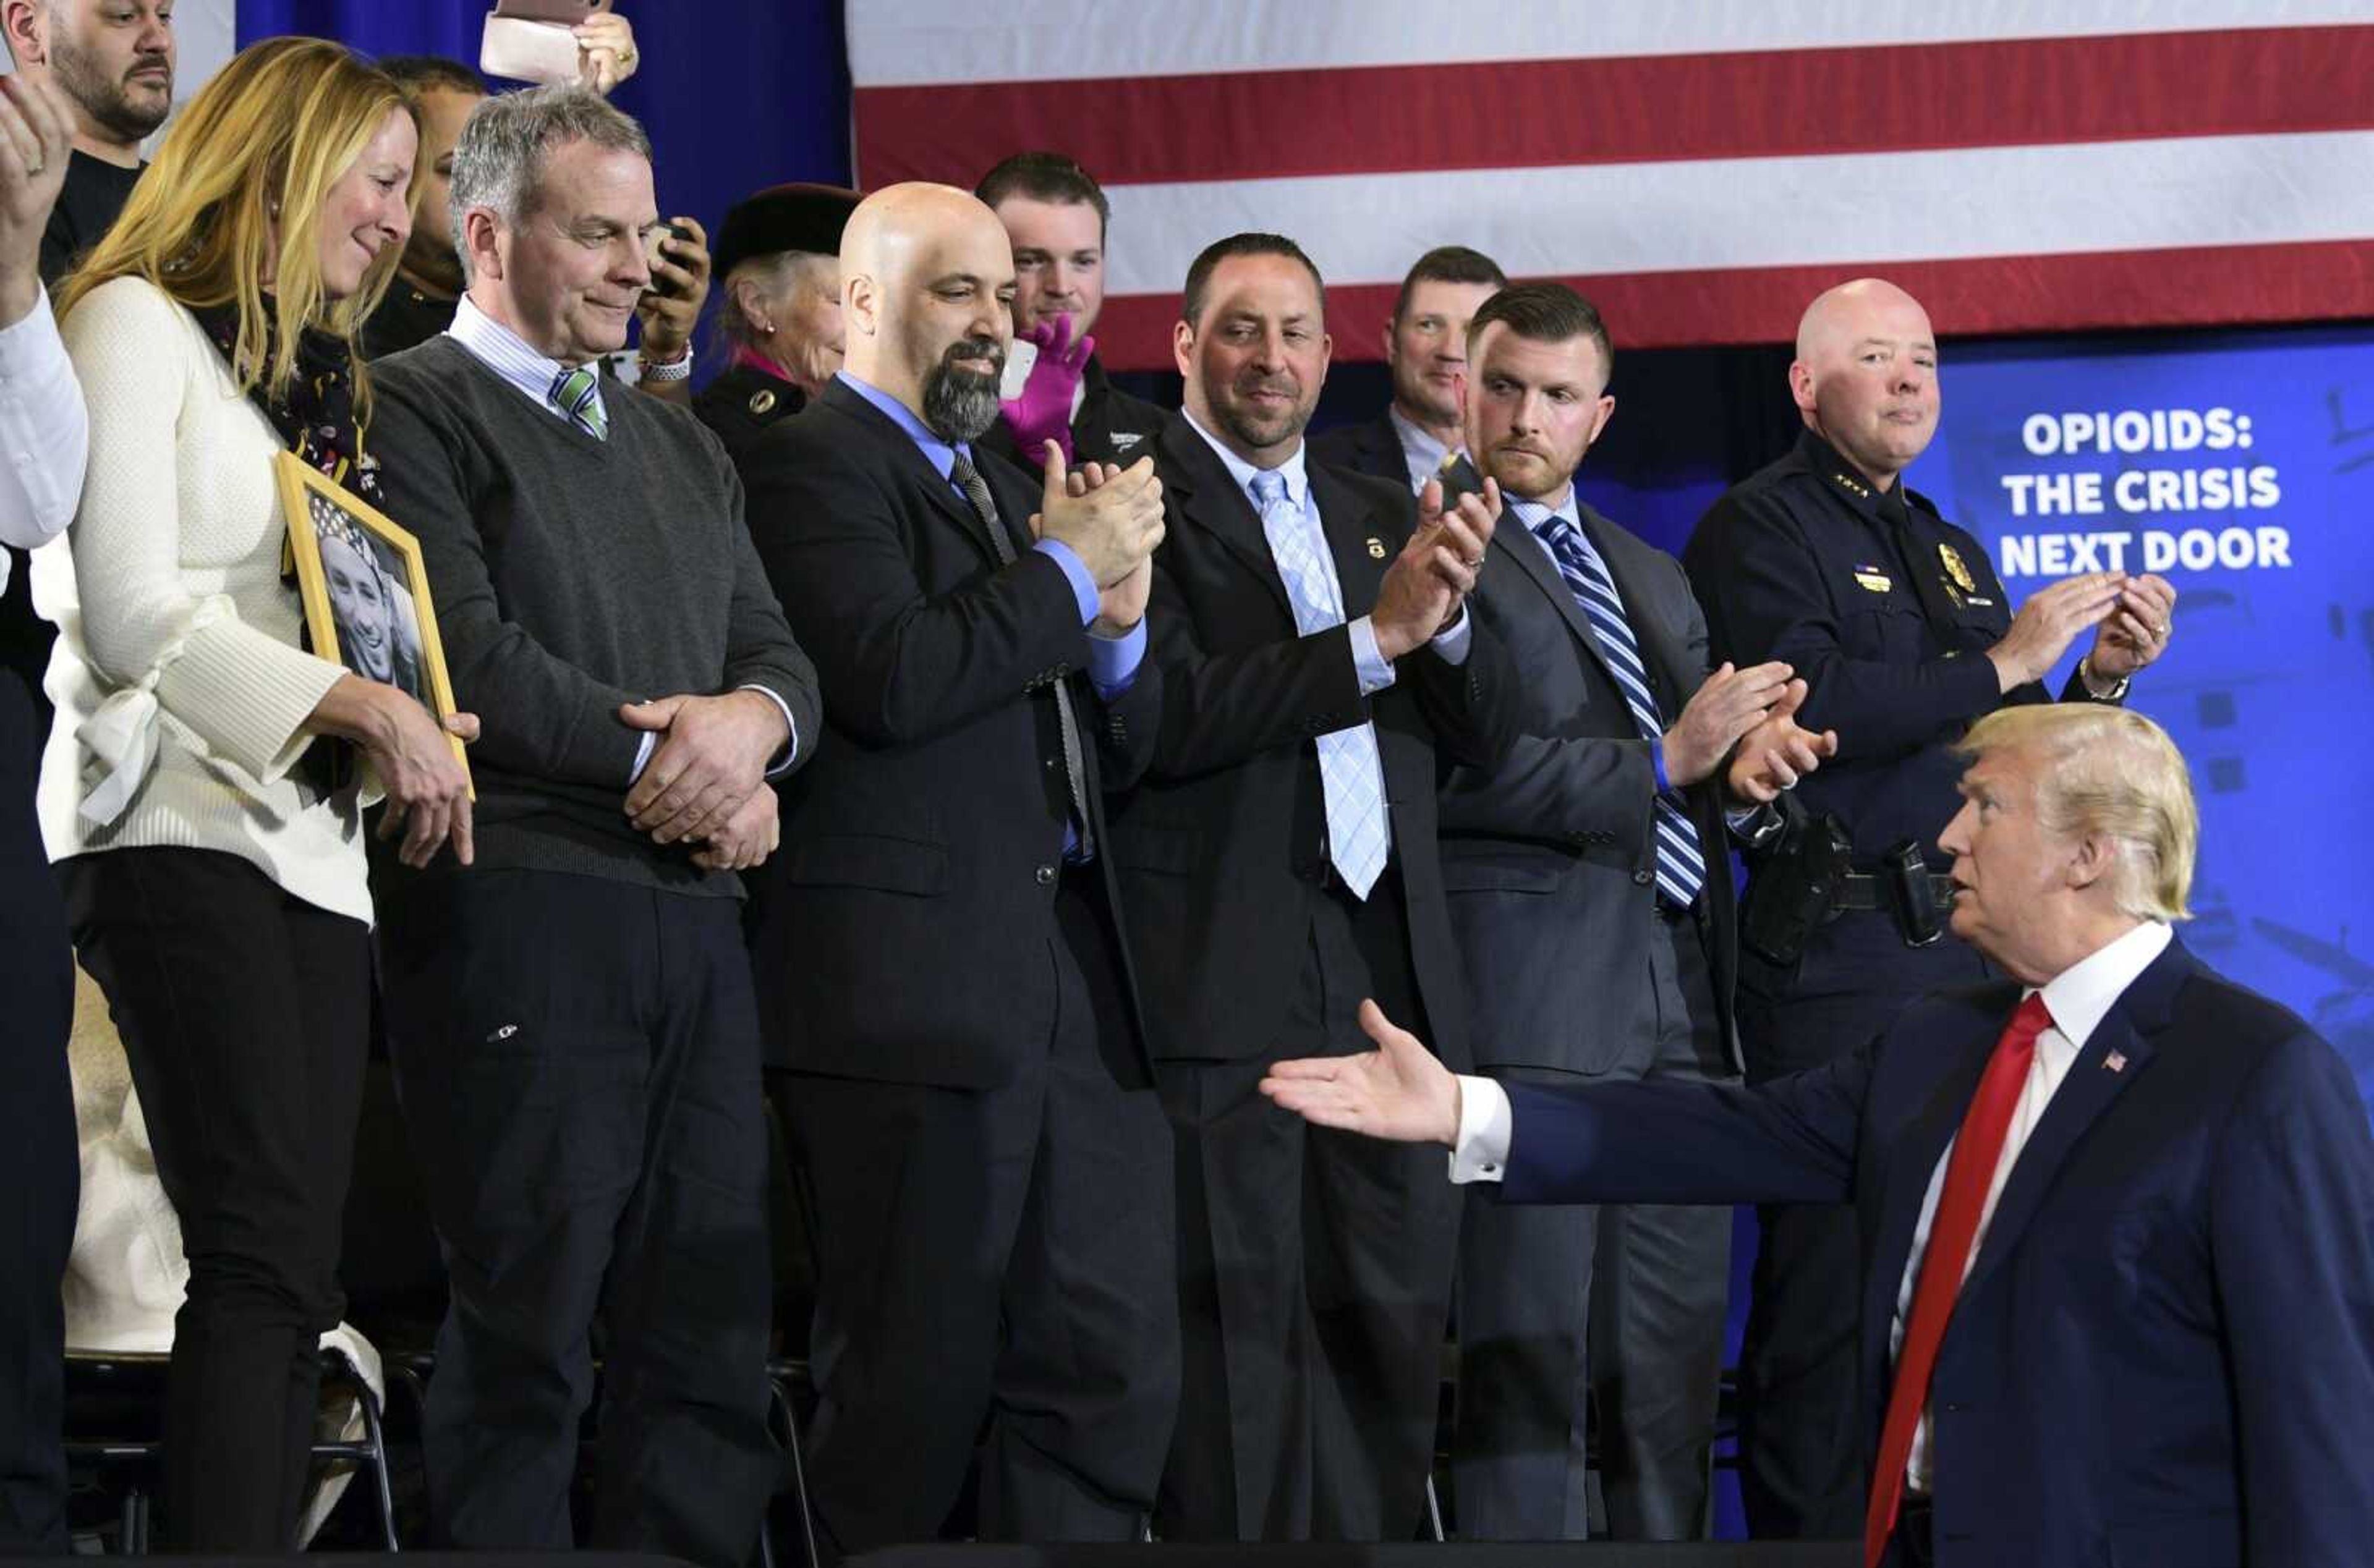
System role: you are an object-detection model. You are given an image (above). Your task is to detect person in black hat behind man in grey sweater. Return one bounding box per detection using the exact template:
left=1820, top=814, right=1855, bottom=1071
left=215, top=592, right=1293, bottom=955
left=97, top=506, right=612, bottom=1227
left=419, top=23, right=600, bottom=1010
left=693, top=183, right=857, bottom=467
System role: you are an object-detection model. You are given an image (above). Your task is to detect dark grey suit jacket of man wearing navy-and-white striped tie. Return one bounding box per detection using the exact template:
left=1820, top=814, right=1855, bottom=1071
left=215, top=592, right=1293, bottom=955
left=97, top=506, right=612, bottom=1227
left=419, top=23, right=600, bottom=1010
left=1441, top=506, right=1738, bottom=1072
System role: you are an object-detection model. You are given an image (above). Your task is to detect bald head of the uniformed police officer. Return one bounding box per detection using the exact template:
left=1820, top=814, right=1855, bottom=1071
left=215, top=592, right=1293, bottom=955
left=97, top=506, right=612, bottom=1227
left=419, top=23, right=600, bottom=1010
left=1788, top=278, right=1937, bottom=491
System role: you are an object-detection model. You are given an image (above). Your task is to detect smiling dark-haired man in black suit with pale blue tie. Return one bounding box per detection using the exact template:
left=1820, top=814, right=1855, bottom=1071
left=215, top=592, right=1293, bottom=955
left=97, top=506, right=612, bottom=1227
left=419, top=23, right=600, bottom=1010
left=1111, top=235, right=1510, bottom=1540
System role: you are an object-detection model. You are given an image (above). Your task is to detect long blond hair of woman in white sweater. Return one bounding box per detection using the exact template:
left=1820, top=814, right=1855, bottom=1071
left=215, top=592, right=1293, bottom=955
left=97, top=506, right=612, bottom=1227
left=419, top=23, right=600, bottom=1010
left=57, top=38, right=420, bottom=415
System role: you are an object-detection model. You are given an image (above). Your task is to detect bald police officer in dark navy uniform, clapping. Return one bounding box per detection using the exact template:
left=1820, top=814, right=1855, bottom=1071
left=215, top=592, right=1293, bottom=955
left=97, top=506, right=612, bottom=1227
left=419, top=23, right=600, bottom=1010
left=1683, top=278, right=2174, bottom=1540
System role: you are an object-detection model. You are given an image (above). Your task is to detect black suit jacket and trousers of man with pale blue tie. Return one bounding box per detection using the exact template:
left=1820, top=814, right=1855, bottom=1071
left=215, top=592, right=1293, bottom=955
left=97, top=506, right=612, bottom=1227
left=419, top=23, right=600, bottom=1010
left=1113, top=415, right=1510, bottom=1540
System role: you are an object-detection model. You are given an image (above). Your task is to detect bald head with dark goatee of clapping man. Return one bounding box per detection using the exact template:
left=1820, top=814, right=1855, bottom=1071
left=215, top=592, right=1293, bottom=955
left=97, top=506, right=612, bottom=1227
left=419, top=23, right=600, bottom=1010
left=840, top=183, right=1014, bottom=441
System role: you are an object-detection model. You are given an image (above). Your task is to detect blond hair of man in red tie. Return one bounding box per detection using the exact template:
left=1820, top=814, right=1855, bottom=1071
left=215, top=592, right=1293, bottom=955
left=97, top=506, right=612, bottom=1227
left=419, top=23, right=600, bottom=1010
left=1956, top=702, right=2201, bottom=920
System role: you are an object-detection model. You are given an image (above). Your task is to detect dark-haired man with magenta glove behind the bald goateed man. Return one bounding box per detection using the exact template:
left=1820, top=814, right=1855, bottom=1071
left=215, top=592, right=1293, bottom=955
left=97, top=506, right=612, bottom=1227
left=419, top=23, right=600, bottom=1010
left=973, top=152, right=1168, bottom=470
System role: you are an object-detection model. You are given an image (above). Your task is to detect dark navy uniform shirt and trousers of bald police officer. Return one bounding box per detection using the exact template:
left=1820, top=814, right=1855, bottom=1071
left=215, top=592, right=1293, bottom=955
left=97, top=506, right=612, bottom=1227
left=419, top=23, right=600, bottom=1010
left=1683, top=432, right=2127, bottom=1540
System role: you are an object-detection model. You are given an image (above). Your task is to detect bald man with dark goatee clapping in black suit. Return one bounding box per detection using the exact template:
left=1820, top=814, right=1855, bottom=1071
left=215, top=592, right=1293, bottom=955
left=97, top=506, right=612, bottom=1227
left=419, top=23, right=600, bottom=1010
left=743, top=185, right=1178, bottom=1551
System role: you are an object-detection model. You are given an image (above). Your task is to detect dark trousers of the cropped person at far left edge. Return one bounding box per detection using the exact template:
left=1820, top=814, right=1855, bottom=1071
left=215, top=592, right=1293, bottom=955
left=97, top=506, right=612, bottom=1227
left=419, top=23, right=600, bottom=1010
left=0, top=664, right=81, bottom=1556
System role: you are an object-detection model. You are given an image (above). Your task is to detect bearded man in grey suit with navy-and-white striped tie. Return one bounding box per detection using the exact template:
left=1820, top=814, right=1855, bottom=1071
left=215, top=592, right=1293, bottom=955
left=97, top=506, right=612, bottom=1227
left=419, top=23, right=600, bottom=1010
left=1441, top=282, right=1831, bottom=1540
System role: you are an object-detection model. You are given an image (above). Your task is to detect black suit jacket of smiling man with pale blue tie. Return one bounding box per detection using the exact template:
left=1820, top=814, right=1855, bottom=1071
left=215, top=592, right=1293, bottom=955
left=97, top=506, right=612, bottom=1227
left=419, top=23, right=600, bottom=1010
left=1113, top=418, right=1512, bottom=1062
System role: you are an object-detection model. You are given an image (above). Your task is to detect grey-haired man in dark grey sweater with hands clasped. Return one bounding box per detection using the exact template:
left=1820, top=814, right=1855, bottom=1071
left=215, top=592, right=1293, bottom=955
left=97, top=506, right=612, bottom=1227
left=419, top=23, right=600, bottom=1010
left=370, top=88, right=822, bottom=1568
